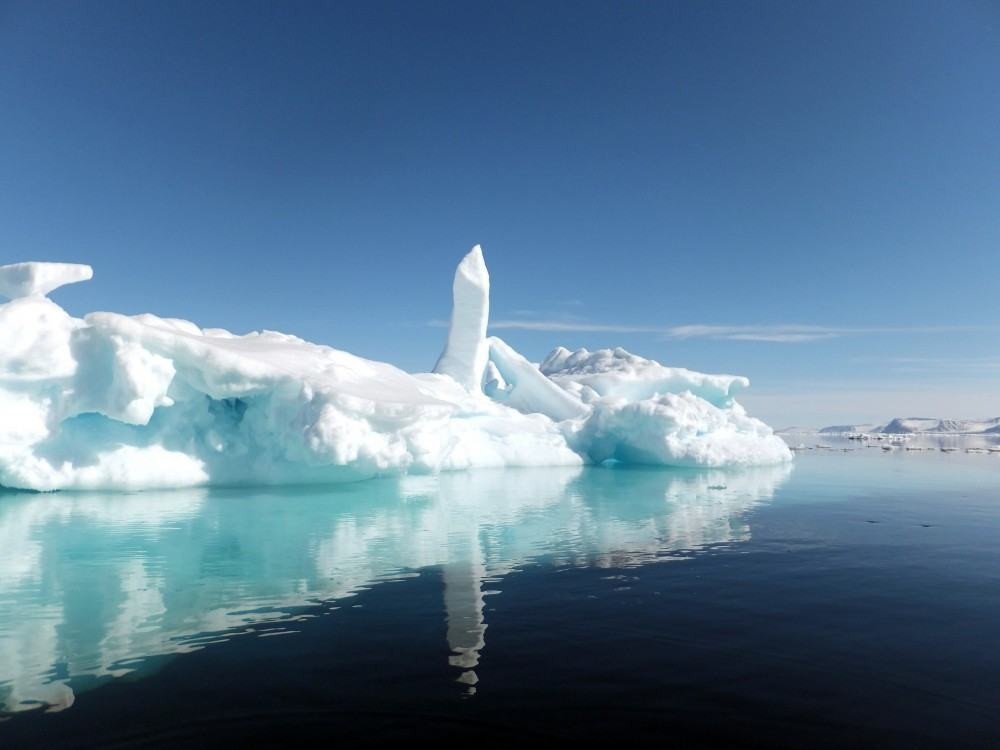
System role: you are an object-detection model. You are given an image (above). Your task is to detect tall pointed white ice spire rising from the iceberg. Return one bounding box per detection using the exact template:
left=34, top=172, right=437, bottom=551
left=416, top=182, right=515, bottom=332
left=434, top=245, right=490, bottom=391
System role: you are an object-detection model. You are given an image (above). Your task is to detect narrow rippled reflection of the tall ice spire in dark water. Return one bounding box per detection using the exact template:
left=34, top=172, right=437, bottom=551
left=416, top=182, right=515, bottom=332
left=444, top=543, right=486, bottom=695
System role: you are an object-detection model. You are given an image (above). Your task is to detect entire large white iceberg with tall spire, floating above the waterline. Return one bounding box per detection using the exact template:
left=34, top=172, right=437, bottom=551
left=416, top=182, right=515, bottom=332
left=0, top=246, right=791, bottom=490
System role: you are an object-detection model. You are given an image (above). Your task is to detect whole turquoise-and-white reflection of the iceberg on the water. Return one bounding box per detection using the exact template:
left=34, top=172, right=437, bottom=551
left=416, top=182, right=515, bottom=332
left=0, top=465, right=792, bottom=711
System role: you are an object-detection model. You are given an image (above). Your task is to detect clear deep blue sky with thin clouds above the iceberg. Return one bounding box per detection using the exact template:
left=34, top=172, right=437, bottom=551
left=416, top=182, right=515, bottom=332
left=0, top=0, right=1000, bottom=426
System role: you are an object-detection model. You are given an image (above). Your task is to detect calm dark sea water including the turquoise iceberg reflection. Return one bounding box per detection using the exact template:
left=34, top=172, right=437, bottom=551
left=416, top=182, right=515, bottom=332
left=0, top=446, right=1000, bottom=748
